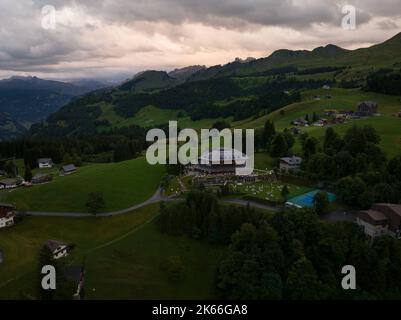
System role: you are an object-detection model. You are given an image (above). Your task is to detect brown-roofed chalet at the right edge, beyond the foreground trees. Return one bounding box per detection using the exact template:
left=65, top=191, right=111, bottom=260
left=356, top=203, right=401, bottom=238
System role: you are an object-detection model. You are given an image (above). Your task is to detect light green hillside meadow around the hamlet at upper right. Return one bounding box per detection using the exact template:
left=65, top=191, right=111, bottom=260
left=239, top=89, right=401, bottom=156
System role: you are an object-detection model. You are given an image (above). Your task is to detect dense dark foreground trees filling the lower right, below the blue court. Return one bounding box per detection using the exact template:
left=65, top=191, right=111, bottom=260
left=158, top=190, right=401, bottom=299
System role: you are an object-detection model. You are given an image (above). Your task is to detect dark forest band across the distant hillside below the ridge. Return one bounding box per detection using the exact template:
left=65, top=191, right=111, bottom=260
left=116, top=78, right=331, bottom=120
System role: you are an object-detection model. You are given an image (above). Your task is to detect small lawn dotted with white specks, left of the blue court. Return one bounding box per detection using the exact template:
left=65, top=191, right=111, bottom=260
left=234, top=182, right=313, bottom=201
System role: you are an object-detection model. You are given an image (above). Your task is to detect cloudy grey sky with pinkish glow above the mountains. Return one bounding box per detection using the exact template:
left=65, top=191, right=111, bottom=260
left=0, top=0, right=401, bottom=79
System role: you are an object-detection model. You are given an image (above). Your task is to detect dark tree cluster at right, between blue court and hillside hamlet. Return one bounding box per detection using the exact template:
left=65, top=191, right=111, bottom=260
left=255, top=121, right=401, bottom=209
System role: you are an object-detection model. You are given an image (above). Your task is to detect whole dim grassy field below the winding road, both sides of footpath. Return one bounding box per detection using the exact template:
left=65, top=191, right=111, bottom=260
left=0, top=204, right=224, bottom=299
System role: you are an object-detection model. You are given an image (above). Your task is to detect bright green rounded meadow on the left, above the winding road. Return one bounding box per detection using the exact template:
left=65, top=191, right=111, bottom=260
left=0, top=158, right=165, bottom=212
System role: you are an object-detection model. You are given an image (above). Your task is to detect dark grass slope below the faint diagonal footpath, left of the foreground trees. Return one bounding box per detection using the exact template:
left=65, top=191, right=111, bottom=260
left=86, top=223, right=224, bottom=299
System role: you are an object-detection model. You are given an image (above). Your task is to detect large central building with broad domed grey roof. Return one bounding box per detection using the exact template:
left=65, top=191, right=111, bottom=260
left=194, top=148, right=248, bottom=174
